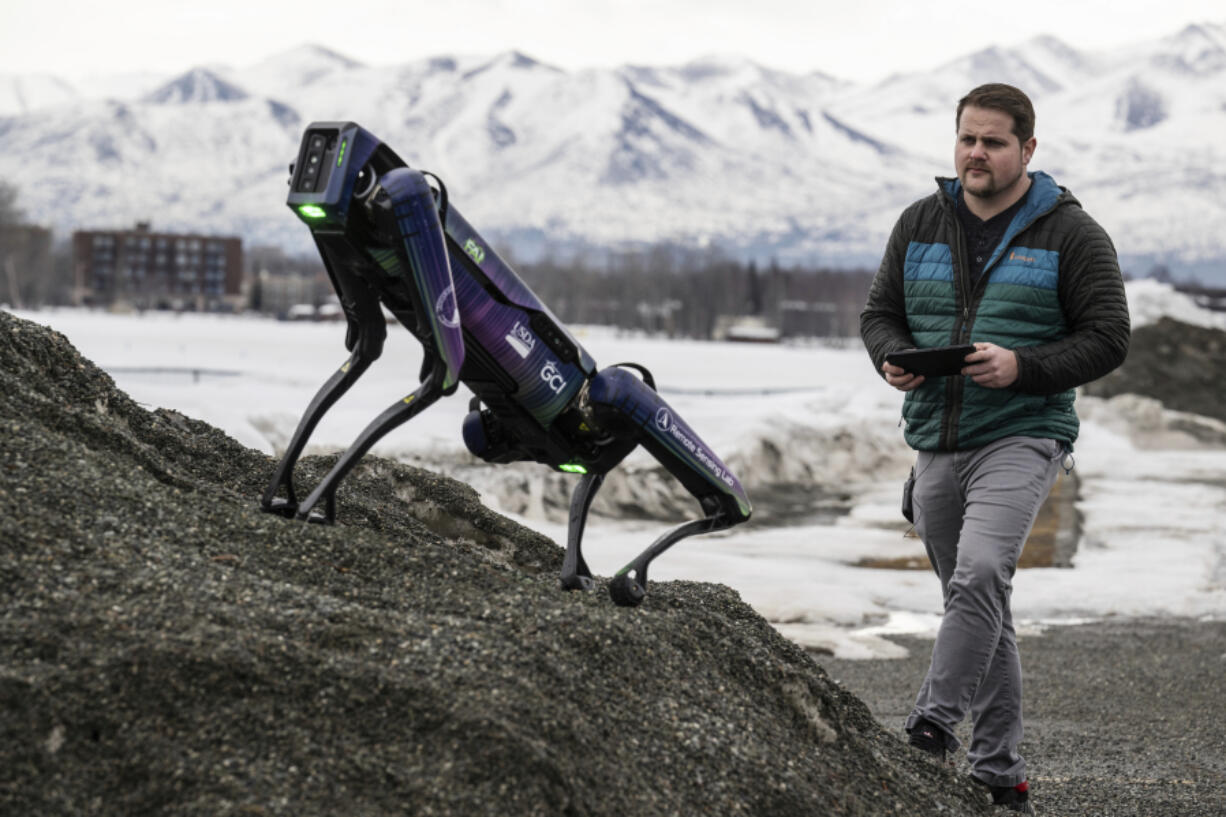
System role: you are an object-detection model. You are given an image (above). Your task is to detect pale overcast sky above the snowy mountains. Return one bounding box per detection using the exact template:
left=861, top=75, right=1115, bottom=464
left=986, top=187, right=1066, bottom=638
left=0, top=0, right=1226, bottom=81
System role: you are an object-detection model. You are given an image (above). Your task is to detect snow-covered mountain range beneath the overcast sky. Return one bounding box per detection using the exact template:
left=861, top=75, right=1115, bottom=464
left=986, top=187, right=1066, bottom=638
left=0, top=23, right=1226, bottom=278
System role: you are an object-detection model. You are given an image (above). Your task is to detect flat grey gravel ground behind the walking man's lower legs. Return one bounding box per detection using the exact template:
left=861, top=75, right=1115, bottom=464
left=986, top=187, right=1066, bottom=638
left=821, top=618, right=1226, bottom=817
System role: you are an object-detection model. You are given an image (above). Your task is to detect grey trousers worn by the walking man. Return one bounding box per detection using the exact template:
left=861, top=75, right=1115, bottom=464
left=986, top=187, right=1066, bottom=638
left=906, top=437, right=1064, bottom=786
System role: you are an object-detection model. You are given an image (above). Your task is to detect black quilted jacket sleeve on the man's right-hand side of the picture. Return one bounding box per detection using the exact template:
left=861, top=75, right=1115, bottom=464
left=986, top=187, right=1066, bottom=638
left=1013, top=207, right=1130, bottom=394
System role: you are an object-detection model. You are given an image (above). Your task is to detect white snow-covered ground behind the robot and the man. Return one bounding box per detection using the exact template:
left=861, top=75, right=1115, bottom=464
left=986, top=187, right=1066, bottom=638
left=11, top=281, right=1226, bottom=658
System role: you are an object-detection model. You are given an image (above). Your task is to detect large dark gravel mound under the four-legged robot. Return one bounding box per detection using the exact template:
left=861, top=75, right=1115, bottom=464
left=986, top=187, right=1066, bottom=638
left=0, top=312, right=989, bottom=817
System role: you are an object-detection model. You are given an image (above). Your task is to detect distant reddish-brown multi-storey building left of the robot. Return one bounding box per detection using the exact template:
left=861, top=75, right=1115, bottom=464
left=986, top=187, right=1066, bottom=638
left=72, top=222, right=244, bottom=310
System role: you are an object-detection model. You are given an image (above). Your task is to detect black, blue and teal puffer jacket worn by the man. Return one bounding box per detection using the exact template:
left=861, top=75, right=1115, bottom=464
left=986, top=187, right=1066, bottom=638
left=861, top=173, right=1129, bottom=451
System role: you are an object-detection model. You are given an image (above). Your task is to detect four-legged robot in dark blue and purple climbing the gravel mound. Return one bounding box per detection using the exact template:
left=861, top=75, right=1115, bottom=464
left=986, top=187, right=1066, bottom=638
left=261, top=121, right=752, bottom=606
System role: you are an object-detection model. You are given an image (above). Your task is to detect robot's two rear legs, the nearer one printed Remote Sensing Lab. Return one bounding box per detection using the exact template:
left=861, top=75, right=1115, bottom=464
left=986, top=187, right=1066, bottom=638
left=573, top=367, right=753, bottom=607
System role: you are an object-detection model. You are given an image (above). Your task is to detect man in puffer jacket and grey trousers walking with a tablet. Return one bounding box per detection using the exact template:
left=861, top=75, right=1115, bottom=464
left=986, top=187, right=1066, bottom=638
left=861, top=85, right=1129, bottom=815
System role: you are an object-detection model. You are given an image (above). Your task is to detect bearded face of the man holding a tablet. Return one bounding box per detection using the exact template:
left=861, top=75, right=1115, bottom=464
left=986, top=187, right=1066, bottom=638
left=954, top=105, right=1035, bottom=199
